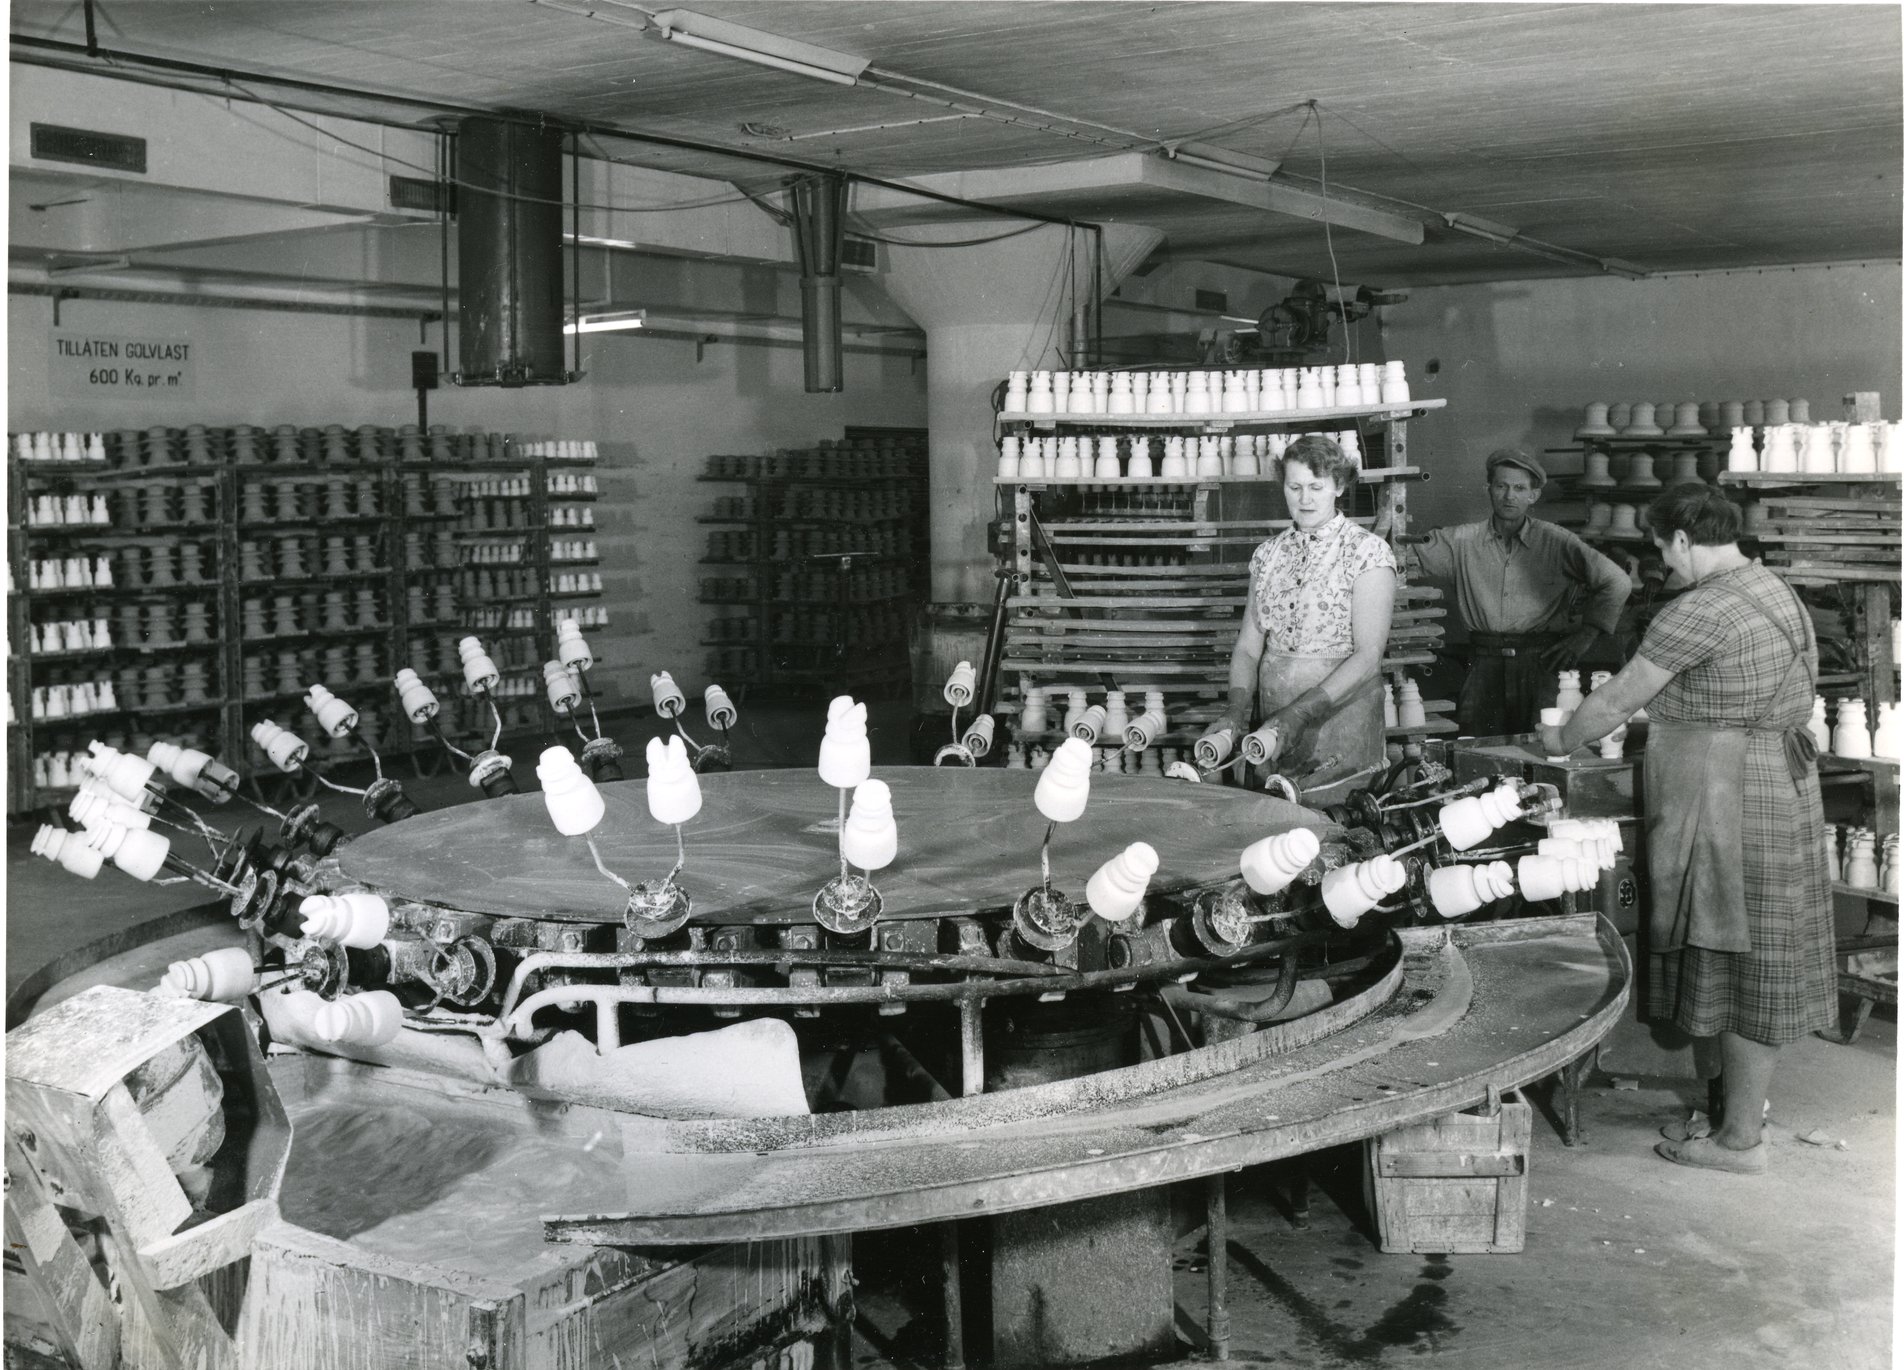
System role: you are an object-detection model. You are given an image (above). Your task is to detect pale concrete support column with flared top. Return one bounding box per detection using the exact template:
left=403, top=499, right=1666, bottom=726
left=882, top=217, right=1163, bottom=603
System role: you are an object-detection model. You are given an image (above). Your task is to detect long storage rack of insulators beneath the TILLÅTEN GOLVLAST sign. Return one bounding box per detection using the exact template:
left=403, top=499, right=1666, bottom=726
left=8, top=424, right=592, bottom=812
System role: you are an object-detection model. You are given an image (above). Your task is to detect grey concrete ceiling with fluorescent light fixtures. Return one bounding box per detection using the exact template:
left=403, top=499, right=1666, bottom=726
left=11, top=0, right=1904, bottom=285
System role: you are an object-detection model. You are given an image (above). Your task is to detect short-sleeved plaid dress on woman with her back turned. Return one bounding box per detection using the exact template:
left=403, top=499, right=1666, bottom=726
left=1639, top=563, right=1837, bottom=1047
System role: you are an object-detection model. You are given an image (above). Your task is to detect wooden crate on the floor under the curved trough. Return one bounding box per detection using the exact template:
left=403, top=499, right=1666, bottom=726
left=1367, top=1092, right=1533, bottom=1254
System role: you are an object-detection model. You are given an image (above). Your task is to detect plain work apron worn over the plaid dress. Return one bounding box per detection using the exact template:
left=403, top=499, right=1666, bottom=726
left=1645, top=586, right=1818, bottom=953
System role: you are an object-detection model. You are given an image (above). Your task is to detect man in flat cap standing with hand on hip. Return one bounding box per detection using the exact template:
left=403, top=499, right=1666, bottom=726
left=1417, top=447, right=1632, bottom=736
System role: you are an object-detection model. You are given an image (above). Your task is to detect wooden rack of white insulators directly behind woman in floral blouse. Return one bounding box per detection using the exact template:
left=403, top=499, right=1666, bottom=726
left=994, top=390, right=1457, bottom=748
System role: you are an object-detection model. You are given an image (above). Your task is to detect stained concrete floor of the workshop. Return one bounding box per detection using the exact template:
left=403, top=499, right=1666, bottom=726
left=6, top=702, right=1896, bottom=1370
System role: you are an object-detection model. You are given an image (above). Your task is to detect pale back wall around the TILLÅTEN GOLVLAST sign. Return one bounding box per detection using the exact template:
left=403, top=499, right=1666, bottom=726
left=8, top=295, right=925, bottom=704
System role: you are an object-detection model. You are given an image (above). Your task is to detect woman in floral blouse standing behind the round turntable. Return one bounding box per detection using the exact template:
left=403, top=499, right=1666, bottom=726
left=1209, top=434, right=1396, bottom=803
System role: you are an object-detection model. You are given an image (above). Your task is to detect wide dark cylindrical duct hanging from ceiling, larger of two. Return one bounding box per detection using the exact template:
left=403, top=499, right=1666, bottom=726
left=453, top=118, right=575, bottom=386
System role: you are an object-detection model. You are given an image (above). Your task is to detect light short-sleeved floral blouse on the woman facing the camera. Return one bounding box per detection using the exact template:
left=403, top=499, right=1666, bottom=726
left=1249, top=514, right=1396, bottom=656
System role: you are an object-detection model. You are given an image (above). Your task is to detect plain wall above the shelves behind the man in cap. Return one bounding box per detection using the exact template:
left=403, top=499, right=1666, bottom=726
left=1382, top=263, right=1904, bottom=525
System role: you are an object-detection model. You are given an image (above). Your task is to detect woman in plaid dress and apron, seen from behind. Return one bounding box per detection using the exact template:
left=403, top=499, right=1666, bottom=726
left=1542, top=483, right=1837, bottom=1172
